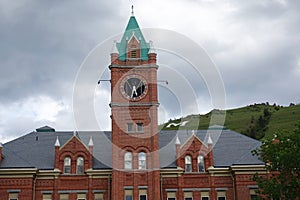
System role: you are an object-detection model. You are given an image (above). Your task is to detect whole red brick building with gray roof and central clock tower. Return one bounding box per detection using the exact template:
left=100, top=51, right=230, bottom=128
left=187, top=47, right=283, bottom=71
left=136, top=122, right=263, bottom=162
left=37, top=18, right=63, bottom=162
left=0, top=12, right=265, bottom=200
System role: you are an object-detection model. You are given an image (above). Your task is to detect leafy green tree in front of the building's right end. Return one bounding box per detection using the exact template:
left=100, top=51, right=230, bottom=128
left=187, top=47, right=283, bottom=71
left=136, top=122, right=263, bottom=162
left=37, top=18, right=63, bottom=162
left=253, top=124, right=300, bottom=200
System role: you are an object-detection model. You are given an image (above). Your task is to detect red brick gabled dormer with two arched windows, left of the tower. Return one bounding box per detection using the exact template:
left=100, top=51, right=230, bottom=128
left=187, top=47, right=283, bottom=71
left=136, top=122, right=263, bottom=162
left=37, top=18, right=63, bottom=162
left=54, top=134, right=93, bottom=175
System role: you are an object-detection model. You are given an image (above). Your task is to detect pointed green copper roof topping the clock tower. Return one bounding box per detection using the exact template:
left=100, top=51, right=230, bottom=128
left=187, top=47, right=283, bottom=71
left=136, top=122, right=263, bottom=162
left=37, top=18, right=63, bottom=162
left=117, top=16, right=150, bottom=60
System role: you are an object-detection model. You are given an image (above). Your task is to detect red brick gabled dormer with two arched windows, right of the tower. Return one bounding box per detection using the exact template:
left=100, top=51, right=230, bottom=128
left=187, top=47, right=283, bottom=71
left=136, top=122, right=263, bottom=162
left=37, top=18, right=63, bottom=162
left=175, top=134, right=213, bottom=173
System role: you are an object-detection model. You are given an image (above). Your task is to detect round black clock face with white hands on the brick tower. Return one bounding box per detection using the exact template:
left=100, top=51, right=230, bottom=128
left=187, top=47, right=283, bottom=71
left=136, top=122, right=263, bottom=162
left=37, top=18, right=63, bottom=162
left=121, top=75, right=148, bottom=101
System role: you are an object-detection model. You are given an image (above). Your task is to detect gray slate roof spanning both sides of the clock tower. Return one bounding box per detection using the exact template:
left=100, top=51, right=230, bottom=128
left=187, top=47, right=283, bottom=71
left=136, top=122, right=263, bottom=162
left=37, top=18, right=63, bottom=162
left=0, top=127, right=263, bottom=169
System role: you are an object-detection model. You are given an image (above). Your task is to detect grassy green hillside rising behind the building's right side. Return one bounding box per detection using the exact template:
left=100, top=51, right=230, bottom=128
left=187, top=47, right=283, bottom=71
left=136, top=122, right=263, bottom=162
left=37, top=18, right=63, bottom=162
left=160, top=103, right=300, bottom=139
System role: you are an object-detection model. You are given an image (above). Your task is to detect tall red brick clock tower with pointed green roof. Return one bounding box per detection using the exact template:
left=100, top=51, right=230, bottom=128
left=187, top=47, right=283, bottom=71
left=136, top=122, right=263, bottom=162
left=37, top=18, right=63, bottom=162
left=109, top=13, right=160, bottom=200
